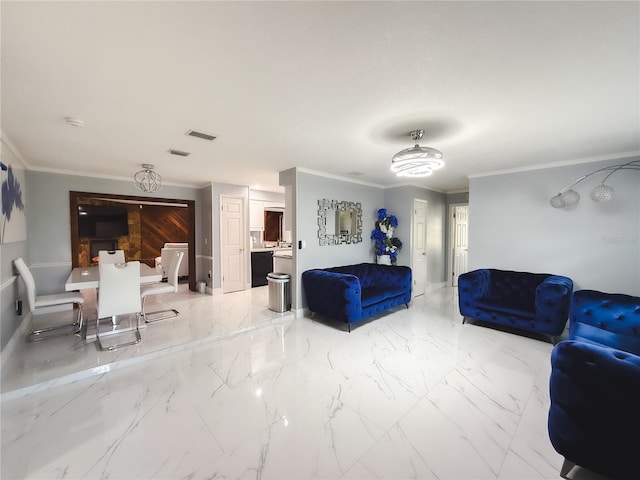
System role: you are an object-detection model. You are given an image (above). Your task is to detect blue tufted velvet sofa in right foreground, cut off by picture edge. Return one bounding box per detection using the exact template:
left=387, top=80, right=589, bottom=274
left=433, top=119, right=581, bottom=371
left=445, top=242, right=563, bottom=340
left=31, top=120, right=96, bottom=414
left=548, top=290, right=640, bottom=480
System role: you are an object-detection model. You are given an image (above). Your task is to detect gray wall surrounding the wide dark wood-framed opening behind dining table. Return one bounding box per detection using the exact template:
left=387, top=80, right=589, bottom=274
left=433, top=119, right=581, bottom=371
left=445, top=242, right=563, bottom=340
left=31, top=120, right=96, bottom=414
left=27, top=171, right=202, bottom=294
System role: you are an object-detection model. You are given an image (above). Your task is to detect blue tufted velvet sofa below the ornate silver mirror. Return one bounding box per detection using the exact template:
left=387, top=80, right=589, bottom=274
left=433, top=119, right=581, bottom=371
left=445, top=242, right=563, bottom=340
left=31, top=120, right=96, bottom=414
left=302, top=263, right=411, bottom=331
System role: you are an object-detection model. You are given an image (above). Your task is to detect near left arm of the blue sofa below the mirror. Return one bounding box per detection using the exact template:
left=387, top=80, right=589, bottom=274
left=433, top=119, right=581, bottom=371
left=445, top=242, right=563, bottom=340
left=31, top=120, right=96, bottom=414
left=302, top=269, right=362, bottom=322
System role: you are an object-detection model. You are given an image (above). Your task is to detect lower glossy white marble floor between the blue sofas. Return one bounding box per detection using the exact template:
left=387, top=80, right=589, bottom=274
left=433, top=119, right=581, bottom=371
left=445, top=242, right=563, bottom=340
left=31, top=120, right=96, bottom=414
left=0, top=288, right=601, bottom=480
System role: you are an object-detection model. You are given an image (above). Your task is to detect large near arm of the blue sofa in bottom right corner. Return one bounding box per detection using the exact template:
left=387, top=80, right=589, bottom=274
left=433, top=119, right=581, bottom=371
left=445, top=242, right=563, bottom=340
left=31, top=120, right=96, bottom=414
left=548, top=340, right=640, bottom=479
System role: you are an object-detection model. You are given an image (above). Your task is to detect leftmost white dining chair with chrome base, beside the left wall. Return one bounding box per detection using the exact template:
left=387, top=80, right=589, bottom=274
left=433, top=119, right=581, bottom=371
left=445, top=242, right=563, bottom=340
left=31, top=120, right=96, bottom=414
left=13, top=258, right=84, bottom=342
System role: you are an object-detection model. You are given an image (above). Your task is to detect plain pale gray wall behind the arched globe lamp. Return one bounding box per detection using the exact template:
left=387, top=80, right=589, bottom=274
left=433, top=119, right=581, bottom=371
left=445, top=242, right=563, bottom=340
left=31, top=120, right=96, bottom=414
left=469, top=159, right=640, bottom=296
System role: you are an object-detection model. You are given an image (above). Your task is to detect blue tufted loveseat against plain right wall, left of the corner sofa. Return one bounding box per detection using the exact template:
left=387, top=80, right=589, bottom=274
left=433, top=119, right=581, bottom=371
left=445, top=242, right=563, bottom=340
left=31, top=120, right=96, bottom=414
left=458, top=268, right=573, bottom=343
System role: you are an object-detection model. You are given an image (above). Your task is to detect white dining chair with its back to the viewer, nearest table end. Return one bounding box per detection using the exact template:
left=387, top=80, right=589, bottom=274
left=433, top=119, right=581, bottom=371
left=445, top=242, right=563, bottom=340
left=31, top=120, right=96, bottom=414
left=96, top=261, right=142, bottom=350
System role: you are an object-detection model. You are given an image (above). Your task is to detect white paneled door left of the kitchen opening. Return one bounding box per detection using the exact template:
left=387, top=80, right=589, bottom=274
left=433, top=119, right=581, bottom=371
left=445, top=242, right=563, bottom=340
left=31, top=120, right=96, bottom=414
left=220, top=196, right=246, bottom=293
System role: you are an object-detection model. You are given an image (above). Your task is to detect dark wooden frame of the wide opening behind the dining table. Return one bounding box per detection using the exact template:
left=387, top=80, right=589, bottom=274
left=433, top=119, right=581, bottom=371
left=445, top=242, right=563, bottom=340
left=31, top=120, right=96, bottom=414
left=69, top=191, right=196, bottom=292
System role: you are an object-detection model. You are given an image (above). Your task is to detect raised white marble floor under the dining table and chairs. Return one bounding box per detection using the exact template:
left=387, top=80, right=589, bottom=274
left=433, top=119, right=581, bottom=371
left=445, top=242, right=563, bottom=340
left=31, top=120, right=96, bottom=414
left=0, top=284, right=293, bottom=400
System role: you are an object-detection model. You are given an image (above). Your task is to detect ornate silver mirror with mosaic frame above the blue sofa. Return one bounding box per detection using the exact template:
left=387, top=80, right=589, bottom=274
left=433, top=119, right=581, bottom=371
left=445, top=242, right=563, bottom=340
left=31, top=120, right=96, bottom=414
left=318, top=198, right=362, bottom=245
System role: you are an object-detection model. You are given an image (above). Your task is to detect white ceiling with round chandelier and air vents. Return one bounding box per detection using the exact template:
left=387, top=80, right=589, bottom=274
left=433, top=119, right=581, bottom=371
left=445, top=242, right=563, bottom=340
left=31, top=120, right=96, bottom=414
left=0, top=1, right=640, bottom=192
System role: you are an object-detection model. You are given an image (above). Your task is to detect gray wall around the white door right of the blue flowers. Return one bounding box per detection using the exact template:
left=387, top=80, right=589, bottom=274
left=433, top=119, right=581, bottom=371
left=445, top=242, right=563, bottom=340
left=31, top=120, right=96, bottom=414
left=384, top=186, right=447, bottom=289
